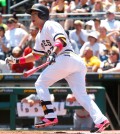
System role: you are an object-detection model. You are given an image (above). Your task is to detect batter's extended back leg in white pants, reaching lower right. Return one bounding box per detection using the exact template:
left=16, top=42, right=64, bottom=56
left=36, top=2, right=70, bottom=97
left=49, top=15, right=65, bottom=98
left=66, top=72, right=109, bottom=132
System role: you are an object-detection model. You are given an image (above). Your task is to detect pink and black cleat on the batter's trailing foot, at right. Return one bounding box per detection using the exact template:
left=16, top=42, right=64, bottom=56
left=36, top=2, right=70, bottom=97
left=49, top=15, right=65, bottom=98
left=90, top=120, right=110, bottom=133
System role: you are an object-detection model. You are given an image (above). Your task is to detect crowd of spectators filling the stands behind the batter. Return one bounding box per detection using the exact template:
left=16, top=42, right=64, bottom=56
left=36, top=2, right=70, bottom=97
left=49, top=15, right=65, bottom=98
left=0, top=0, right=120, bottom=73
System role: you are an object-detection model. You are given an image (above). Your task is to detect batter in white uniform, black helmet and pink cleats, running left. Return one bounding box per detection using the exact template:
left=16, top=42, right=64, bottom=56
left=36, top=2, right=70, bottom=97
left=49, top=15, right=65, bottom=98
left=6, top=4, right=110, bottom=132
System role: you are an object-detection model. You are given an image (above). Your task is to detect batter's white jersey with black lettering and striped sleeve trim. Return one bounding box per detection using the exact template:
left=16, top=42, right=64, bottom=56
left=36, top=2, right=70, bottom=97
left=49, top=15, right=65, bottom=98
left=33, top=20, right=73, bottom=55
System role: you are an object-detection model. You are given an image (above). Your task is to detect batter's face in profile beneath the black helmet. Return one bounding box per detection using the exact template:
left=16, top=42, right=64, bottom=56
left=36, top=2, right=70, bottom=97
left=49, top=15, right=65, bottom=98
left=31, top=11, right=41, bottom=27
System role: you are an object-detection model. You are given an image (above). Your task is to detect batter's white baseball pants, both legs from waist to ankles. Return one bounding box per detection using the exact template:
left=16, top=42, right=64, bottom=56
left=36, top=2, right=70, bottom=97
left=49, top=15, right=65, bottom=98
left=35, top=52, right=107, bottom=124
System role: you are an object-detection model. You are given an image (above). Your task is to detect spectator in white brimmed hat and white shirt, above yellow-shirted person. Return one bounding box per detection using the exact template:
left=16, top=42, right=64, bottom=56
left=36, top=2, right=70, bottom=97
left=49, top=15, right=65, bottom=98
left=80, top=32, right=101, bottom=57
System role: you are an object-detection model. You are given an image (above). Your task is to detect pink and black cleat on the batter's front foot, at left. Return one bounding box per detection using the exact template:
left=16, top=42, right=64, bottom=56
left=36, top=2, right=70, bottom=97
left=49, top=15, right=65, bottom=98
left=35, top=118, right=58, bottom=128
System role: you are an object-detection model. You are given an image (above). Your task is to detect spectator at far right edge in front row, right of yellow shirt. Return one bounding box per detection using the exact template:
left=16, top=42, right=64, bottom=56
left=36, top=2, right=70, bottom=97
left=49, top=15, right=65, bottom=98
left=98, top=49, right=120, bottom=72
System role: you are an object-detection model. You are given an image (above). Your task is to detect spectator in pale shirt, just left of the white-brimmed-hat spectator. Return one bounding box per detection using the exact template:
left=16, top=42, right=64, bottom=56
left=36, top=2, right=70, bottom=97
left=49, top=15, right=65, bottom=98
left=70, top=20, right=88, bottom=49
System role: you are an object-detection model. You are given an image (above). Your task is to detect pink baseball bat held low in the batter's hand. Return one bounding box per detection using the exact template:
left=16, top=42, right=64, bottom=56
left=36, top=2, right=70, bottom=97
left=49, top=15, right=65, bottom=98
left=23, top=62, right=49, bottom=77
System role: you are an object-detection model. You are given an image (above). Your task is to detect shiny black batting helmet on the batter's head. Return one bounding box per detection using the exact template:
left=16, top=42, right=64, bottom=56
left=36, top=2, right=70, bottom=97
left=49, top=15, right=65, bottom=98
left=28, top=3, right=49, bottom=20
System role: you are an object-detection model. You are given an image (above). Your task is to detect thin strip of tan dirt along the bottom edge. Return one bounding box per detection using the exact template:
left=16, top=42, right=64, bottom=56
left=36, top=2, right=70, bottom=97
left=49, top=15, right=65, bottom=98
left=0, top=130, right=120, bottom=134
